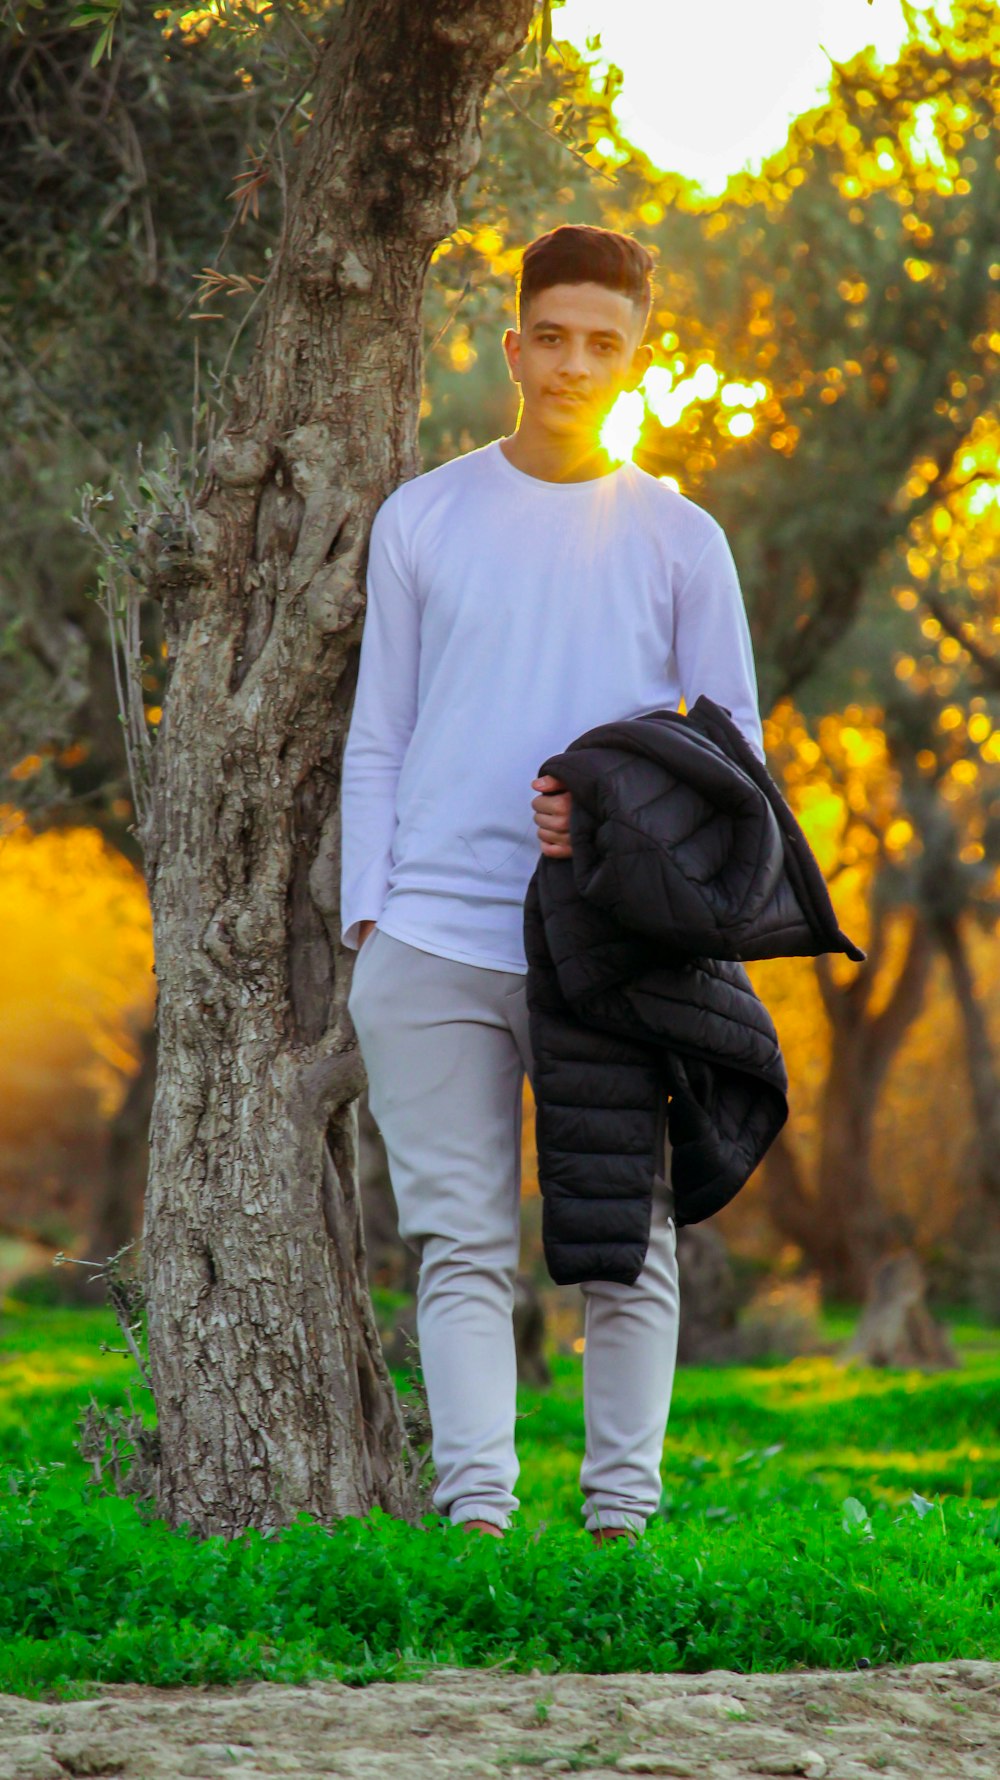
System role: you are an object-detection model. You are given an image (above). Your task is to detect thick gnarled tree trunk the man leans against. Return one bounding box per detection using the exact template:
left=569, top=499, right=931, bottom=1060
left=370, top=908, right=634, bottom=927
left=141, top=0, right=532, bottom=1536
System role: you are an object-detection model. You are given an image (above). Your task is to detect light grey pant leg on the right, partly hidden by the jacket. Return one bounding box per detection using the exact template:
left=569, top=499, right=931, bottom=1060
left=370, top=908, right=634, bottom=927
left=507, top=988, right=680, bottom=1533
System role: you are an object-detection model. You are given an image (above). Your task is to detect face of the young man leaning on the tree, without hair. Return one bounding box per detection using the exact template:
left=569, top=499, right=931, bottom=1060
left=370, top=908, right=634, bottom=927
left=504, top=285, right=651, bottom=443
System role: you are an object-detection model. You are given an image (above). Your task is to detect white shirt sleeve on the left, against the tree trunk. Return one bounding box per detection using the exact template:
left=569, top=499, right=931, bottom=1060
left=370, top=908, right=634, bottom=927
left=340, top=495, right=420, bottom=951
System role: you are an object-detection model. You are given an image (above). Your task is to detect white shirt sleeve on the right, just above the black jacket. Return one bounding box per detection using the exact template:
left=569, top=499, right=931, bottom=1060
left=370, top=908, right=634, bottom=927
left=674, top=525, right=763, bottom=760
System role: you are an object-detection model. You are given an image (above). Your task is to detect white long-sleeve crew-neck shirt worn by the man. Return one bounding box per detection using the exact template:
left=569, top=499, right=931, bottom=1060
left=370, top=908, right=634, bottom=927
left=340, top=440, right=763, bottom=972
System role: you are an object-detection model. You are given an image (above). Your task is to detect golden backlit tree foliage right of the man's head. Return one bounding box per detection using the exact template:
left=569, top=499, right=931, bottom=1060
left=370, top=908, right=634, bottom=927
left=626, top=0, right=1000, bottom=712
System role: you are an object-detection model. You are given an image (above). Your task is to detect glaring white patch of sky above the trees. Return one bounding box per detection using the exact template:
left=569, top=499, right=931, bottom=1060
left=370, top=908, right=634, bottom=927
left=552, top=0, right=934, bottom=194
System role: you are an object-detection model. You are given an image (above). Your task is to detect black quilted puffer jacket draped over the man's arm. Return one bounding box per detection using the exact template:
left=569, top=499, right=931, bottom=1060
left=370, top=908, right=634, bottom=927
left=525, top=698, right=865, bottom=1285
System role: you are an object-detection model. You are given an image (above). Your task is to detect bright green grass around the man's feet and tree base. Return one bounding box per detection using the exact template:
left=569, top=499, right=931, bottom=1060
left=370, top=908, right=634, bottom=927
left=0, top=1299, right=1000, bottom=1698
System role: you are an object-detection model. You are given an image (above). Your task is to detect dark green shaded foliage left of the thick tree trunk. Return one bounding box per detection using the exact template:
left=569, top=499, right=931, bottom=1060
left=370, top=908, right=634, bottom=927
left=0, top=0, right=277, bottom=818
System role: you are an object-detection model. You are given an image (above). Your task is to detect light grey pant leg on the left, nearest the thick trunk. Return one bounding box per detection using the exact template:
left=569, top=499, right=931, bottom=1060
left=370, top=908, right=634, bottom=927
left=347, top=927, right=523, bottom=1527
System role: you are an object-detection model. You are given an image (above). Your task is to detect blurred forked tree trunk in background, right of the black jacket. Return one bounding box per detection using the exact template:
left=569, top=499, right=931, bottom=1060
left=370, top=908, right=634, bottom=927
left=763, top=913, right=932, bottom=1301
